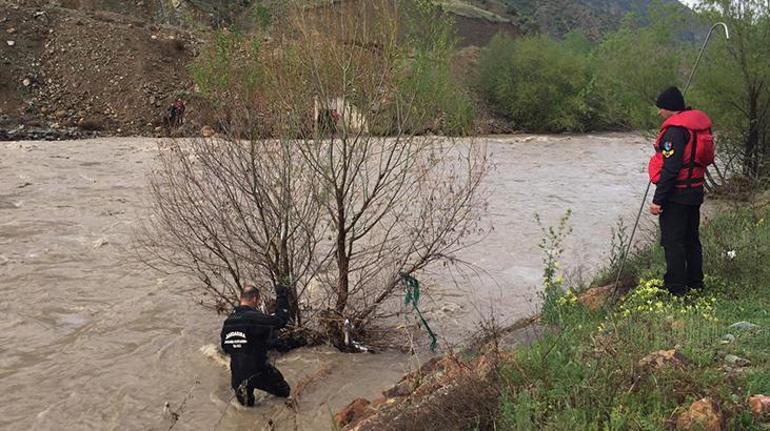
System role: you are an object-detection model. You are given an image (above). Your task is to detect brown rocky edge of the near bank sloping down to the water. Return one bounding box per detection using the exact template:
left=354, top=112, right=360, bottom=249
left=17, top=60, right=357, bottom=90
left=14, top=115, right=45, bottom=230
left=334, top=286, right=608, bottom=431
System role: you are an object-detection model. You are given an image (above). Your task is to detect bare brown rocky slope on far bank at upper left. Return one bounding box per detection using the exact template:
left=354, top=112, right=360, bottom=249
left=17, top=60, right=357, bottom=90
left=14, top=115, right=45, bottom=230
left=0, top=0, right=202, bottom=140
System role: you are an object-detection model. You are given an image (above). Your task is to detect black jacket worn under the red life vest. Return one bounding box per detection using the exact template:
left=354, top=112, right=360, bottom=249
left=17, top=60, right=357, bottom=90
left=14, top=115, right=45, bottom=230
left=652, top=126, right=703, bottom=207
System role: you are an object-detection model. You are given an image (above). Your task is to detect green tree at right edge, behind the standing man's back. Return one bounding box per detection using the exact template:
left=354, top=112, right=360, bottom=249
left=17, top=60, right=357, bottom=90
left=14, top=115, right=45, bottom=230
left=693, top=0, right=770, bottom=179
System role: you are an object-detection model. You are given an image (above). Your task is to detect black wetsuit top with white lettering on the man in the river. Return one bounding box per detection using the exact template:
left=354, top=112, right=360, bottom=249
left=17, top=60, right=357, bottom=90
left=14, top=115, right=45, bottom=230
left=220, top=292, right=289, bottom=388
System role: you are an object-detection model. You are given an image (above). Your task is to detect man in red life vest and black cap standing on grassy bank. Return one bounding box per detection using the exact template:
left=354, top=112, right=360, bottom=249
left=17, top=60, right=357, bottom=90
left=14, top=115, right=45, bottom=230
left=649, top=87, right=714, bottom=296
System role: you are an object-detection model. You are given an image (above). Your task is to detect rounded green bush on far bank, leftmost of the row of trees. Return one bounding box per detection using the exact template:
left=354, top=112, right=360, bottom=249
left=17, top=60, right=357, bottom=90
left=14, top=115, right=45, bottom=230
left=478, top=34, right=590, bottom=132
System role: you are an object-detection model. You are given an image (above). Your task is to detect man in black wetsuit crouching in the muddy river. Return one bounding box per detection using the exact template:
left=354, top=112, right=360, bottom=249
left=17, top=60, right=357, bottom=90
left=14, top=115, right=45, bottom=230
left=221, top=285, right=291, bottom=407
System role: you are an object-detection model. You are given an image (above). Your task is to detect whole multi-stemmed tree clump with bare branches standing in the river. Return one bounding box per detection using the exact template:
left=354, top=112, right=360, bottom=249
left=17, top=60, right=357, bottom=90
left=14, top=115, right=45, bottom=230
left=138, top=0, right=488, bottom=345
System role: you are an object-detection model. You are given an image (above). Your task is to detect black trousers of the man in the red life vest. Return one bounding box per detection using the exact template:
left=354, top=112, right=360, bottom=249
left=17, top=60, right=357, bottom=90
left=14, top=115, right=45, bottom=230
left=660, top=202, right=703, bottom=295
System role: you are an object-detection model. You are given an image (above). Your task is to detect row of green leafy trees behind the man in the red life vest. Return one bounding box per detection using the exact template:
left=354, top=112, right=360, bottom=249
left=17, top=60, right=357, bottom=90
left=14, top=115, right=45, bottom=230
left=477, top=0, right=770, bottom=182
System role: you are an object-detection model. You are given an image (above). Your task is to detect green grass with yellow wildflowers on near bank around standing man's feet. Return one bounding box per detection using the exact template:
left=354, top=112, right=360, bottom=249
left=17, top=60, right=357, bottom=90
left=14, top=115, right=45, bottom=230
left=498, top=205, right=770, bottom=430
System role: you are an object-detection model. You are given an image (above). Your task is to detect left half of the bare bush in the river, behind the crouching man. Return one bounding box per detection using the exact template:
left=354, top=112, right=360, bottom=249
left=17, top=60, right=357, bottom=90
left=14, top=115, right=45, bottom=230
left=140, top=121, right=322, bottom=325
